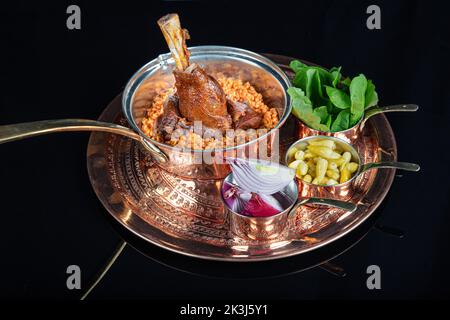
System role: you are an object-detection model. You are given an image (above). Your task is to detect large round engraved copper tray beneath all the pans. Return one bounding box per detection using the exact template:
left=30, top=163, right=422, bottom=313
left=87, top=55, right=397, bottom=261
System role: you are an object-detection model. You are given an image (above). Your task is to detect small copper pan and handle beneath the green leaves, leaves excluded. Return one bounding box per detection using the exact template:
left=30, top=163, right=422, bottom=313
left=298, top=104, right=419, bottom=144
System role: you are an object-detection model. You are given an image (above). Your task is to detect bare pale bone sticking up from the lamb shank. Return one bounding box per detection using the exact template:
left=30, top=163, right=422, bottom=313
left=158, top=13, right=189, bottom=71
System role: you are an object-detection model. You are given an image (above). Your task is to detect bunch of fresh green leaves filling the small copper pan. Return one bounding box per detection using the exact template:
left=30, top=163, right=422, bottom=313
left=288, top=60, right=378, bottom=131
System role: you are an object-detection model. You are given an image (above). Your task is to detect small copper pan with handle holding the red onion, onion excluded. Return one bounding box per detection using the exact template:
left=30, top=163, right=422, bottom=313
left=221, top=173, right=357, bottom=241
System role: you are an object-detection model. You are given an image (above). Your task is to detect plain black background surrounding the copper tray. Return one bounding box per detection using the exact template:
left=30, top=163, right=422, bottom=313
left=0, top=0, right=450, bottom=299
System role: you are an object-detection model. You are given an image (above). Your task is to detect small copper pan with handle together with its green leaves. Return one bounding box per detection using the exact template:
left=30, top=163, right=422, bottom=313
left=288, top=60, right=418, bottom=143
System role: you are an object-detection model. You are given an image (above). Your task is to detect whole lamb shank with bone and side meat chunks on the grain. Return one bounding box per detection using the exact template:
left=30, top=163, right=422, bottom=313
left=156, top=13, right=262, bottom=138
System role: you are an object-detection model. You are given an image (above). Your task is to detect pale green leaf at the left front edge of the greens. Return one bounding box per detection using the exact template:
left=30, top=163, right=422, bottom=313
left=288, top=87, right=329, bottom=131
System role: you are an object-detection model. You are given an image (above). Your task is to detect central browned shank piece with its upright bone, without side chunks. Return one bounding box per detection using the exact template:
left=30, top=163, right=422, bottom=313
left=158, top=14, right=232, bottom=131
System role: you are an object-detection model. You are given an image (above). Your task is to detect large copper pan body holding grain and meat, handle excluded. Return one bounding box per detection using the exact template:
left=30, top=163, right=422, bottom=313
left=122, top=46, right=291, bottom=179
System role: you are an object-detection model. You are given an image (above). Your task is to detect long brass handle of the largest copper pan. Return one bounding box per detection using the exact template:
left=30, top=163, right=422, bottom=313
left=0, top=119, right=168, bottom=163
